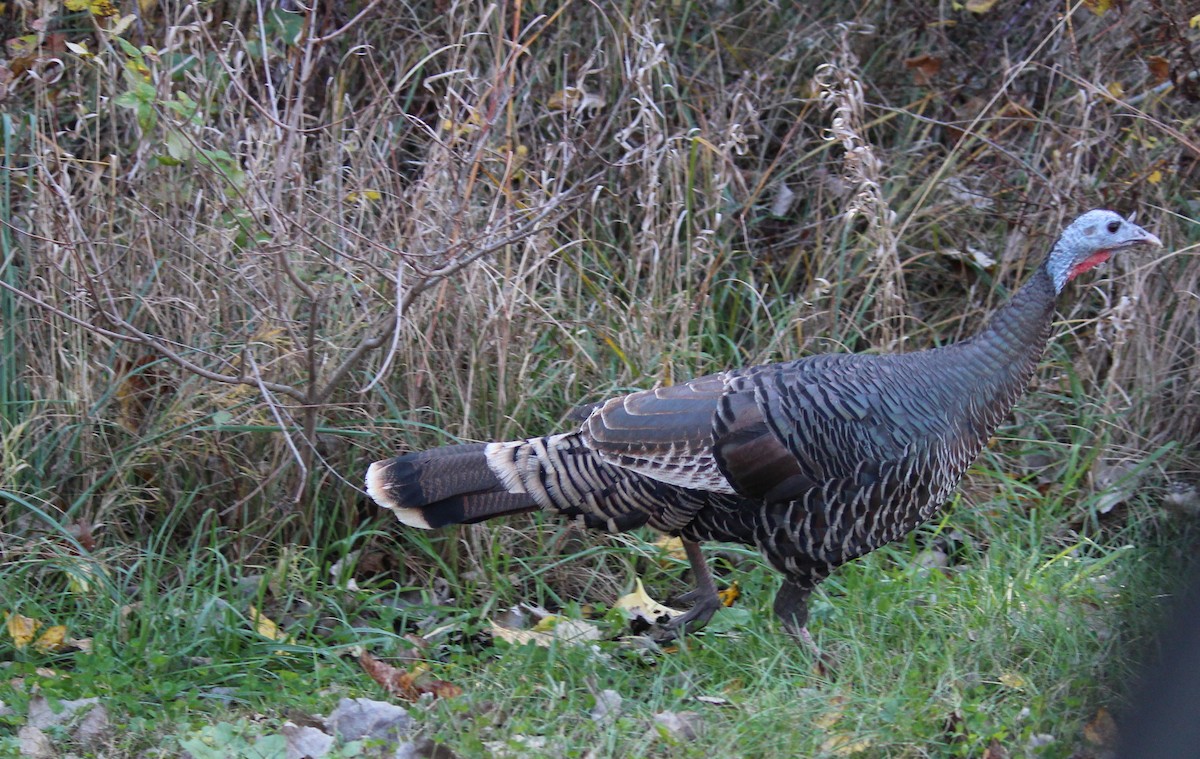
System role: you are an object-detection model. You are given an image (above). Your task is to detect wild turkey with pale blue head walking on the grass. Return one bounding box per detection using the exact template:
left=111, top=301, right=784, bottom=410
left=366, top=210, right=1162, bottom=643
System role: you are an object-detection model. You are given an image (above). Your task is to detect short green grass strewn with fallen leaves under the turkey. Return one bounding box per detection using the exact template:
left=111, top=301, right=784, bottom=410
left=0, top=439, right=1182, bottom=757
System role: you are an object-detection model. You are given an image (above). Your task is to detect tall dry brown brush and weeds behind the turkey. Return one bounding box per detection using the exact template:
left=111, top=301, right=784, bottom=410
left=0, top=0, right=1200, bottom=554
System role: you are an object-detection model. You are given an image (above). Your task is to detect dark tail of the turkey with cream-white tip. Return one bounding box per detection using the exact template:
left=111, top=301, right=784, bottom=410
left=366, top=444, right=538, bottom=530
